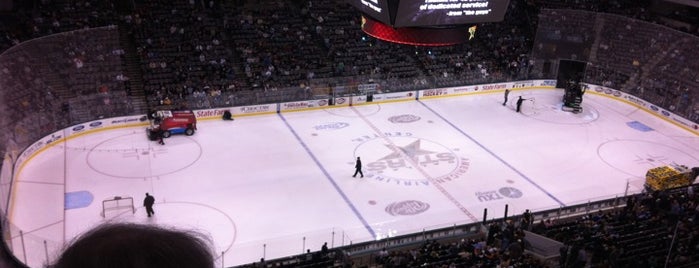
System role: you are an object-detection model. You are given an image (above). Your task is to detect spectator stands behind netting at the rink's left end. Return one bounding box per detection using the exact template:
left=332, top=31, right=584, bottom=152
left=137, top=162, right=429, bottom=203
left=0, top=1, right=134, bottom=157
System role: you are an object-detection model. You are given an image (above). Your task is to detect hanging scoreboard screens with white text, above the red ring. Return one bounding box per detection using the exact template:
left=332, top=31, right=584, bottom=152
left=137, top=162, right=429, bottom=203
left=348, top=0, right=510, bottom=27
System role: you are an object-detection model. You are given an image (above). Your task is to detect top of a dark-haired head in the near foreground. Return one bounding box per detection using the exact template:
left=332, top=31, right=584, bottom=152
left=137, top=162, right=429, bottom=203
left=49, top=223, right=214, bottom=268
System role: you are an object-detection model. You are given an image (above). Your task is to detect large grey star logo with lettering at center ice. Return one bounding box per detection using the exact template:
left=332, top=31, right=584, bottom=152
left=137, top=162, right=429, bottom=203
left=352, top=132, right=470, bottom=186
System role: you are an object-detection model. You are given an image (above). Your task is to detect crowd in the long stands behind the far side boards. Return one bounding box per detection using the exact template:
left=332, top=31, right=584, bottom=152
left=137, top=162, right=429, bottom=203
left=115, top=0, right=531, bottom=108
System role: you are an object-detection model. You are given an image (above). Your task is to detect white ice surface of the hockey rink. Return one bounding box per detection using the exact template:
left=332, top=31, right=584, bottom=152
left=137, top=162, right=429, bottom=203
left=10, top=89, right=699, bottom=267
